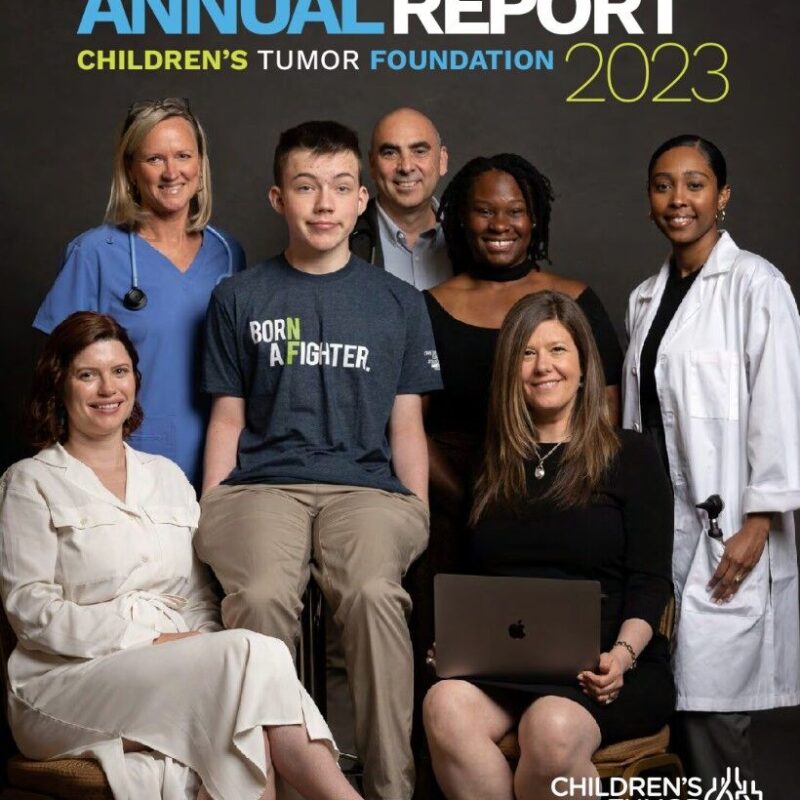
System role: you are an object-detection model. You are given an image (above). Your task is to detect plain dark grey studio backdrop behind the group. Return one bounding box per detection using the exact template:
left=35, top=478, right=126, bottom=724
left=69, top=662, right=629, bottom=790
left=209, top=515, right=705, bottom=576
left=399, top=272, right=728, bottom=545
left=0, top=0, right=800, bottom=800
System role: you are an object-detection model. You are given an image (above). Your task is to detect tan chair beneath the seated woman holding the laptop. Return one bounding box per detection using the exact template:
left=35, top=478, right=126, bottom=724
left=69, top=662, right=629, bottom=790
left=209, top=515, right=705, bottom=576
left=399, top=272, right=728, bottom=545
left=490, top=600, right=686, bottom=800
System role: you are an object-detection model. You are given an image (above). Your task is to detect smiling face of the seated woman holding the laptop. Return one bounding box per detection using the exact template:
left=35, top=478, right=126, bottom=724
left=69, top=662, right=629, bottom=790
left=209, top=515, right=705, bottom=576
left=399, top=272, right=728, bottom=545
left=520, top=320, right=581, bottom=440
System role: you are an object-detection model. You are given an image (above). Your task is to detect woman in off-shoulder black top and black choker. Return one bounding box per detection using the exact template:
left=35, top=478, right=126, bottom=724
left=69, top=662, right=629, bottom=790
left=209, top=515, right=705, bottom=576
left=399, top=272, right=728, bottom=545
left=425, top=153, right=622, bottom=509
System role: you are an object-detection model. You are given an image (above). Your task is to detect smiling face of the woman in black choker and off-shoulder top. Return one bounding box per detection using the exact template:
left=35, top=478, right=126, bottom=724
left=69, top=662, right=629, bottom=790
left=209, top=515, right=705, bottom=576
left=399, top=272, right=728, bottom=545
left=464, top=169, right=533, bottom=268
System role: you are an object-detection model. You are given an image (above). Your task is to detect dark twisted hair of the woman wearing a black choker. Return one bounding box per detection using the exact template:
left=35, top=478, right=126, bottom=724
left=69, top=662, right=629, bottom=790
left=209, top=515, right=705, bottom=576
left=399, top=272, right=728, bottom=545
left=437, top=153, right=554, bottom=274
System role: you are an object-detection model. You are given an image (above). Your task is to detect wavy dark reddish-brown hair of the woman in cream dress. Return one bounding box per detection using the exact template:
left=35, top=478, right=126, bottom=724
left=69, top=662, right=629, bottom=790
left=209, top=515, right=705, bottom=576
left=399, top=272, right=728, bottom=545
left=25, top=311, right=144, bottom=449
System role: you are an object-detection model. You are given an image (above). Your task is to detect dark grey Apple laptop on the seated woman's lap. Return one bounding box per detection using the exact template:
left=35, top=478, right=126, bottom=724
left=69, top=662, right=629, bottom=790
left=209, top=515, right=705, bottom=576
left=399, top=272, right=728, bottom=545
left=434, top=574, right=600, bottom=683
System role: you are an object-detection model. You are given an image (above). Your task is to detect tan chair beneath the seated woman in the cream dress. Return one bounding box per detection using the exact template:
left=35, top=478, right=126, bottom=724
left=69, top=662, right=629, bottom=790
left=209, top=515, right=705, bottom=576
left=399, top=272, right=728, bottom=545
left=0, top=610, right=114, bottom=800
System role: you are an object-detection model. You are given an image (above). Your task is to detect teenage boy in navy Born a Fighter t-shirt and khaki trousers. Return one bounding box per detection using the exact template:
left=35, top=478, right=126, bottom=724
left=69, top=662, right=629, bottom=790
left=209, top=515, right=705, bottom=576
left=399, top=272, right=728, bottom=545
left=196, top=122, right=441, bottom=800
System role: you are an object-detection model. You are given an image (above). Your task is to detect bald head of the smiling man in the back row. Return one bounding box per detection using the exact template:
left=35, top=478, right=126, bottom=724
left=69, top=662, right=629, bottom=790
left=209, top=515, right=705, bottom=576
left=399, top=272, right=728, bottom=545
left=369, top=108, right=447, bottom=218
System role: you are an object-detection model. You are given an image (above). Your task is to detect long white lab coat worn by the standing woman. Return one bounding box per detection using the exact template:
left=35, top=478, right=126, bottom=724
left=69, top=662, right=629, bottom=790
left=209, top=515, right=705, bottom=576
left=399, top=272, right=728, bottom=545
left=623, top=233, right=800, bottom=712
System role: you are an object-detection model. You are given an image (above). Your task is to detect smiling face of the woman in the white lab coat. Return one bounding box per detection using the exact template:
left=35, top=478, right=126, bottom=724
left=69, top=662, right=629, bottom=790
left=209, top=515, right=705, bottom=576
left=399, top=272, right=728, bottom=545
left=648, top=147, right=730, bottom=263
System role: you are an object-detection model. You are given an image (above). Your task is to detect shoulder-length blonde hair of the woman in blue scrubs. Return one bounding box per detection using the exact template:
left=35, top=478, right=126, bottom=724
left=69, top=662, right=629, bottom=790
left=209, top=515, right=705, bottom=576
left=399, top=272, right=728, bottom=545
left=105, top=97, right=211, bottom=233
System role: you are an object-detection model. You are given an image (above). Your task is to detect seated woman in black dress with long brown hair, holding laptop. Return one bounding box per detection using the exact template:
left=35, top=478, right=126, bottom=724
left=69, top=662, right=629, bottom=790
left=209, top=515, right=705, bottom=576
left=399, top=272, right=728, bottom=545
left=424, top=291, right=674, bottom=800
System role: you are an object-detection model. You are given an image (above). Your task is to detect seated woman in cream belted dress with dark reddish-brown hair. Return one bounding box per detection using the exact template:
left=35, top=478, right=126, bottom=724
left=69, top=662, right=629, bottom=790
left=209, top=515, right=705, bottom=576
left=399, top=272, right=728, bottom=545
left=0, top=311, right=358, bottom=800
